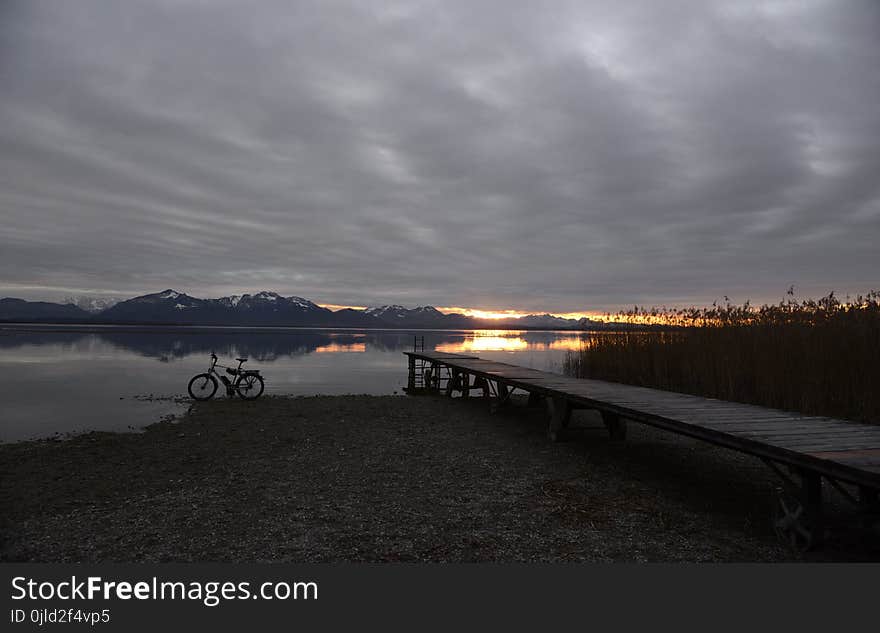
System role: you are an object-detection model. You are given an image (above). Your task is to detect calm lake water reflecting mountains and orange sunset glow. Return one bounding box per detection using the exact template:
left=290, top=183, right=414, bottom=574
left=0, top=326, right=590, bottom=441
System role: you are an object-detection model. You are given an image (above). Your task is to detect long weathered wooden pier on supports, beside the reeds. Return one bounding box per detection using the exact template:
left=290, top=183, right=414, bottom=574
left=405, top=350, right=880, bottom=550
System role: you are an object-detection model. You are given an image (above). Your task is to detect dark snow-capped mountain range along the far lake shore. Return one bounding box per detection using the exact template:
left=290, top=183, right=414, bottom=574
left=0, top=289, right=607, bottom=329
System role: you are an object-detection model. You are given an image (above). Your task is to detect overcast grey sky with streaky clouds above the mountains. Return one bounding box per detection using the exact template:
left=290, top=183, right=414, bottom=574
left=0, top=0, right=880, bottom=313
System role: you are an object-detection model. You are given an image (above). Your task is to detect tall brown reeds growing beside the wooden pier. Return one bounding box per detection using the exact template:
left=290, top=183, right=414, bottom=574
left=564, top=290, right=880, bottom=423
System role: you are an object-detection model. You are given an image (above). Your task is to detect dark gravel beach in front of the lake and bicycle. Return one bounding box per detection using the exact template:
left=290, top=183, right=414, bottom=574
left=0, top=396, right=880, bottom=562
